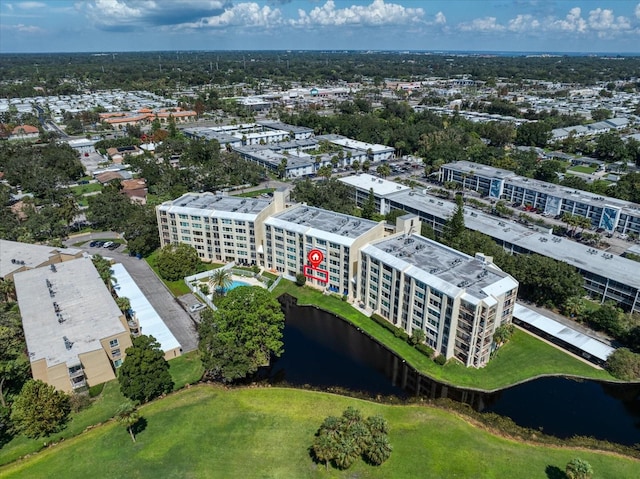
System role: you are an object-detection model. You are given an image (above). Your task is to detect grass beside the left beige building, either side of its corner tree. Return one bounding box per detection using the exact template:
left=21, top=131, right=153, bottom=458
left=0, top=351, right=203, bottom=468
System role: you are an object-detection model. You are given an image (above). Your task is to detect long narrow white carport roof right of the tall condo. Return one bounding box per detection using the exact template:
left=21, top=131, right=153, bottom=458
left=513, top=303, right=615, bottom=361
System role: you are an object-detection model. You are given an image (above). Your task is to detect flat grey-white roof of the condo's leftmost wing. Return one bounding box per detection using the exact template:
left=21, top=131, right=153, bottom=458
left=160, top=193, right=270, bottom=219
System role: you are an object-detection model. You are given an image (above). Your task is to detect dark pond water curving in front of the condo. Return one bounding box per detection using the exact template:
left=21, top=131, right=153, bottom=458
left=268, top=297, right=640, bottom=445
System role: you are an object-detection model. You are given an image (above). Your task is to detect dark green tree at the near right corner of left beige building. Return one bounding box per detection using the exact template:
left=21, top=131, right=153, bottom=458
left=118, top=334, right=173, bottom=403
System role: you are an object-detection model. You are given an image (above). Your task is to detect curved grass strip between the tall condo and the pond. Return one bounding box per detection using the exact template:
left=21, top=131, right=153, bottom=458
left=274, top=280, right=615, bottom=391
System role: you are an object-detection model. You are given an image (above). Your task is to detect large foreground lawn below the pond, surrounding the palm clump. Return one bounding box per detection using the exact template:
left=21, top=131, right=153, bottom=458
left=0, top=385, right=640, bottom=479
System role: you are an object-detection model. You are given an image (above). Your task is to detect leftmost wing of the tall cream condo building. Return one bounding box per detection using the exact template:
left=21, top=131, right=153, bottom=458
left=156, top=191, right=284, bottom=265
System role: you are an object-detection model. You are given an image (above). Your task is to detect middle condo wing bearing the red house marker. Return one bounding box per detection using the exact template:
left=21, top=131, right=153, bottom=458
left=264, top=205, right=384, bottom=298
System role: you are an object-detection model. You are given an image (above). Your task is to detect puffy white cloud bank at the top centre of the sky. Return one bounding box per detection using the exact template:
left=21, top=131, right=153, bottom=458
left=290, top=0, right=422, bottom=27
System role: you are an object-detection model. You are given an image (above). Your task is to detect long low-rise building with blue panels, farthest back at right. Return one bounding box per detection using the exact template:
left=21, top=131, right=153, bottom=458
left=440, top=161, right=640, bottom=234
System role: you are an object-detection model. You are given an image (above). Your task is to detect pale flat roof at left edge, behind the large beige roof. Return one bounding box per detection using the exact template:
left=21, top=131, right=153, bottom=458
left=0, top=239, right=82, bottom=278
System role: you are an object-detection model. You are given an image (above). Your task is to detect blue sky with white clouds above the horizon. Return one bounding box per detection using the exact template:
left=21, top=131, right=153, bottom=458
left=0, top=0, right=640, bottom=53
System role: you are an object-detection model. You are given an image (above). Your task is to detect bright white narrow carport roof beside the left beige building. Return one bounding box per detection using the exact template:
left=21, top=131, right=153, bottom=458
left=111, top=263, right=180, bottom=353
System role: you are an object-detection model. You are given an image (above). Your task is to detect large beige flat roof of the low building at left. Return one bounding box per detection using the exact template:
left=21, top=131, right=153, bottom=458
left=15, top=258, right=126, bottom=367
